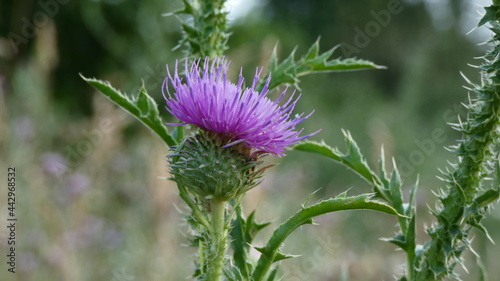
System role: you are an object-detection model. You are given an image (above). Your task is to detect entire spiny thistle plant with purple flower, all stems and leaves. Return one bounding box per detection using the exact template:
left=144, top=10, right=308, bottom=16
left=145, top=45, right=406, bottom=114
left=80, top=0, right=500, bottom=281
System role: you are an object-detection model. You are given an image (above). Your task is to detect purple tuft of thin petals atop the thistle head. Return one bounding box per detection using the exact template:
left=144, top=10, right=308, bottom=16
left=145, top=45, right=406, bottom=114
left=163, top=58, right=317, bottom=155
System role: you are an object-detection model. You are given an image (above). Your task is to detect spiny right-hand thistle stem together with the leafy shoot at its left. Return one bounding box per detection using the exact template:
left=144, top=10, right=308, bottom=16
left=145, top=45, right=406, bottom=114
left=295, top=2, right=500, bottom=281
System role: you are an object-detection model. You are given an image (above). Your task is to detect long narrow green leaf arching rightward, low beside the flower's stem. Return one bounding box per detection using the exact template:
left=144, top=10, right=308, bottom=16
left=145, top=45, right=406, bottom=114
left=252, top=194, right=402, bottom=281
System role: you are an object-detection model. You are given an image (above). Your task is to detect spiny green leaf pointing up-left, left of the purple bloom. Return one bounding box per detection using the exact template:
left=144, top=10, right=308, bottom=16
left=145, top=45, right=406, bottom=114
left=80, top=74, right=177, bottom=146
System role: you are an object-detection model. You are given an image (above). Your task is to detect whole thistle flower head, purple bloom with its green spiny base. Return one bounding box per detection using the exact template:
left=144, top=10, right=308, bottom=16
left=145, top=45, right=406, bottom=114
left=163, top=58, right=318, bottom=201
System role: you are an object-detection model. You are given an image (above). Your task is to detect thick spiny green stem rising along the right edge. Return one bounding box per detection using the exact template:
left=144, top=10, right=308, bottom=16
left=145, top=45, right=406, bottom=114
left=415, top=5, right=500, bottom=280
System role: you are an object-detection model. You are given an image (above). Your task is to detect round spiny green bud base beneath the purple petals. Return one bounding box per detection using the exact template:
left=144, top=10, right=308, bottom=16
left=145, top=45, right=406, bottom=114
left=168, top=132, right=263, bottom=200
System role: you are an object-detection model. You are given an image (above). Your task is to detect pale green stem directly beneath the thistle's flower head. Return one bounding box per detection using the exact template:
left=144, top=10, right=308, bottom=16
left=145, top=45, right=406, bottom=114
left=207, top=199, right=227, bottom=281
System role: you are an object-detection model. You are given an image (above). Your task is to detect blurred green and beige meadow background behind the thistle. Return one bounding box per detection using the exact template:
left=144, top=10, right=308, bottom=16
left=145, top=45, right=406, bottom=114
left=0, top=0, right=500, bottom=281
